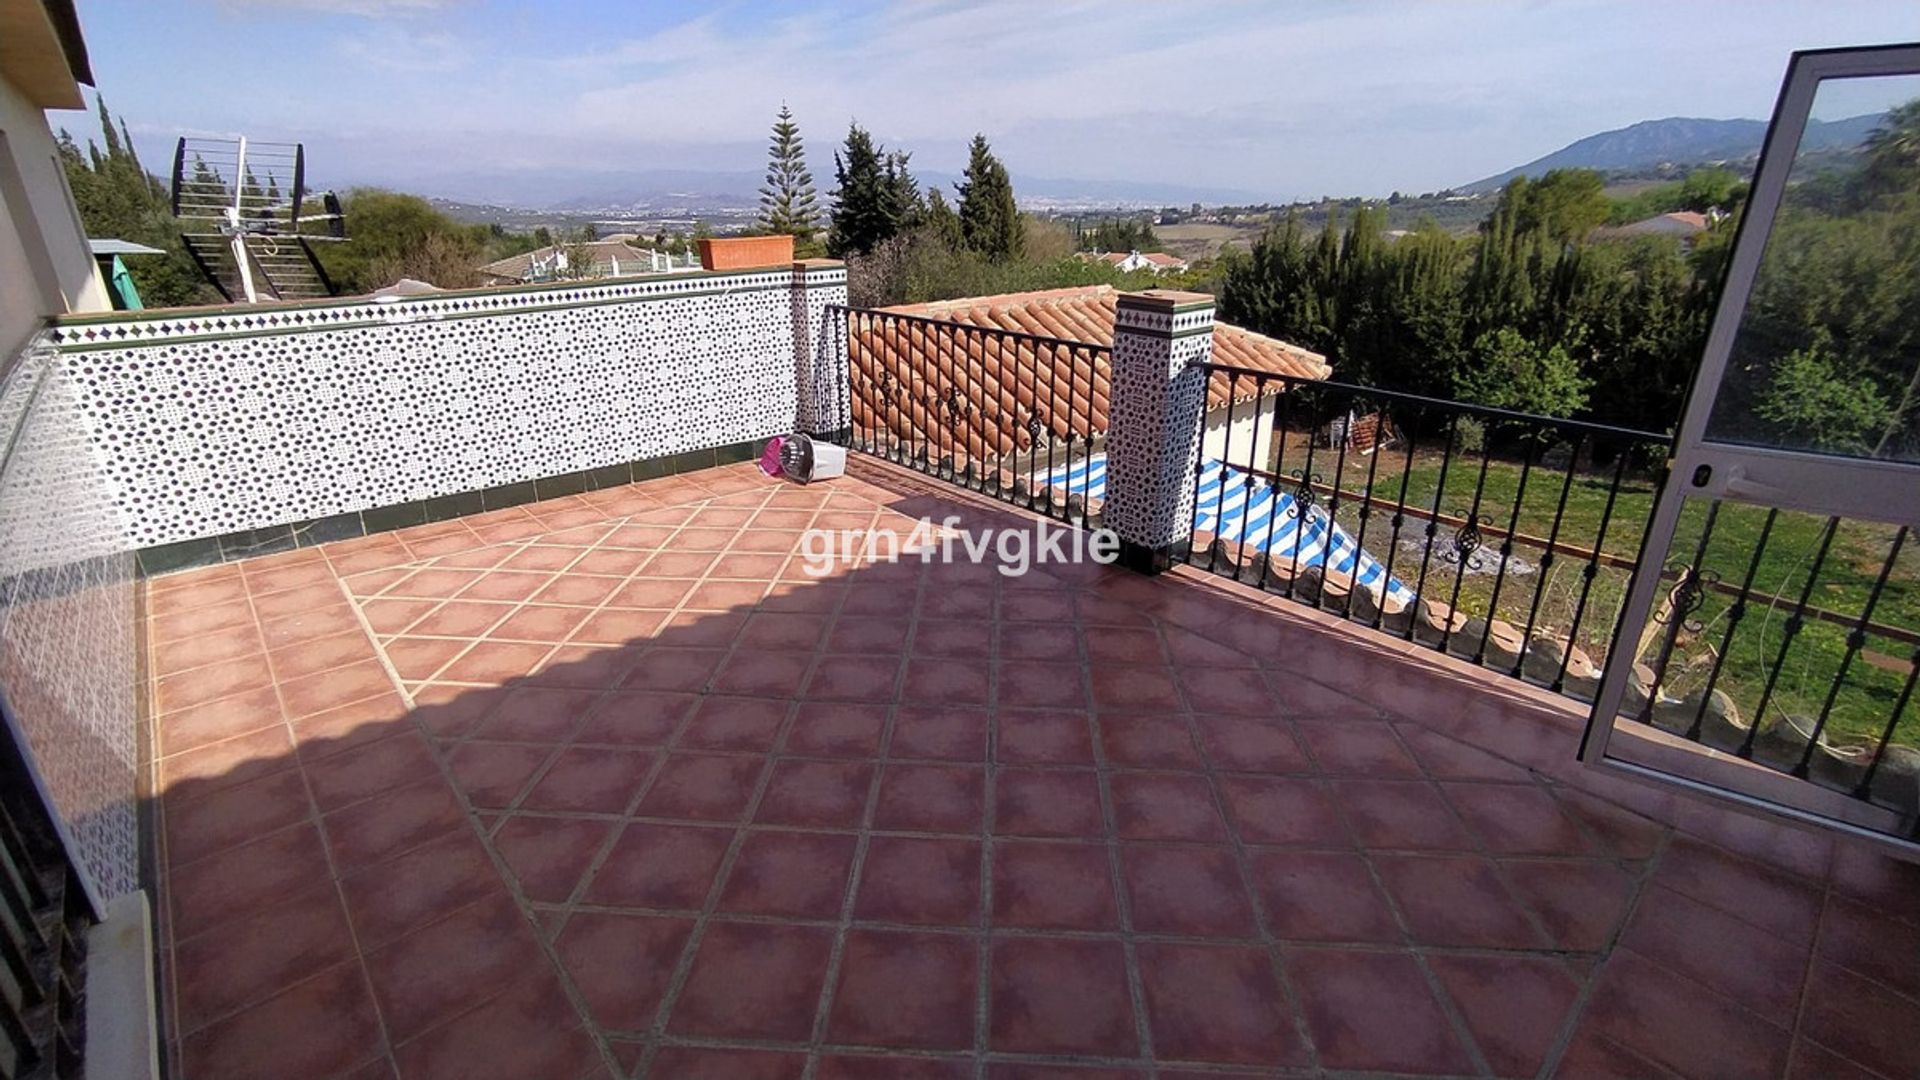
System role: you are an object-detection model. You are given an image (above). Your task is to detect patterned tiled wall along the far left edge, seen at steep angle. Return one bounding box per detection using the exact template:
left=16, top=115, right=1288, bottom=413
left=0, top=342, right=138, bottom=899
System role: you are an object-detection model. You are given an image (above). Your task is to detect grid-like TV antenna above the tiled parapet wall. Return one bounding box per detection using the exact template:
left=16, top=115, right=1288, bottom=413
left=173, top=138, right=348, bottom=304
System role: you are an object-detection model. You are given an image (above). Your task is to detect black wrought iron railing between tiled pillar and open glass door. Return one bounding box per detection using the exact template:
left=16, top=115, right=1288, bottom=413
left=1187, top=363, right=1668, bottom=700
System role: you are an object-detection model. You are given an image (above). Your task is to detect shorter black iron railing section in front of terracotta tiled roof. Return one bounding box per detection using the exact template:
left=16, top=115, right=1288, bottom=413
left=828, top=306, right=1110, bottom=523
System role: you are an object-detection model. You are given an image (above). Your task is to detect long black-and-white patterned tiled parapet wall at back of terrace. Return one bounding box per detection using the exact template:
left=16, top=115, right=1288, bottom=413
left=52, top=263, right=845, bottom=548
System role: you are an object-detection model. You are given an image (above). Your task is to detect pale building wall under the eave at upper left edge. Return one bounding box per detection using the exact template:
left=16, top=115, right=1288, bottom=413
left=0, top=75, right=113, bottom=359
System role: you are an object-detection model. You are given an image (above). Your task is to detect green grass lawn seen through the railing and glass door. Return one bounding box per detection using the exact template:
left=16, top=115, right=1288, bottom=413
left=1279, top=432, right=1920, bottom=746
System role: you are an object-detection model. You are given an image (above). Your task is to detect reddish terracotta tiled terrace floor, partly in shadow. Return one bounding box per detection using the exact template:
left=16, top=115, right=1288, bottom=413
left=148, top=455, right=1920, bottom=1080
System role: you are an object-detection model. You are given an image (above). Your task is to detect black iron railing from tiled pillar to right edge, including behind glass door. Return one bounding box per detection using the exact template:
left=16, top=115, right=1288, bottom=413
left=1185, top=363, right=1920, bottom=826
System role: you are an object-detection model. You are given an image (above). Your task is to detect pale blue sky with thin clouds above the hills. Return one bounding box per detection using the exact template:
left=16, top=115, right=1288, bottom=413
left=67, top=0, right=1920, bottom=202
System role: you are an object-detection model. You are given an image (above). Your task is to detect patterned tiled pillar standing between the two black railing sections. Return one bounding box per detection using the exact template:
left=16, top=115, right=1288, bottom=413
left=1100, top=288, right=1213, bottom=575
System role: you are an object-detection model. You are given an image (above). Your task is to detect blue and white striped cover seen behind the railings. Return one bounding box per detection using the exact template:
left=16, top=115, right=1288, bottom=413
left=1035, top=454, right=1413, bottom=605
